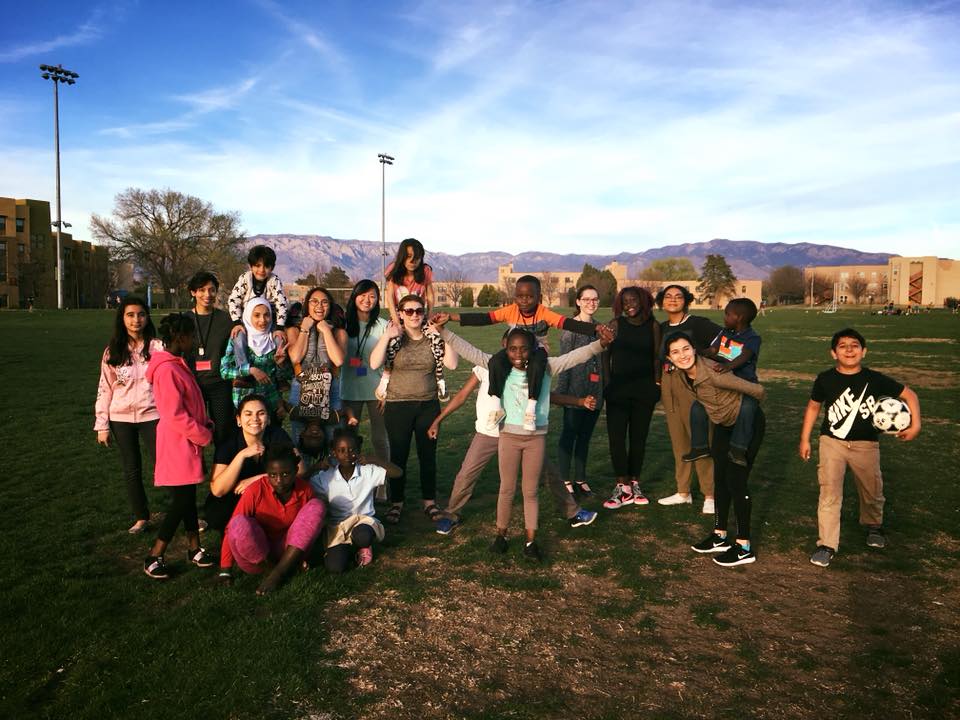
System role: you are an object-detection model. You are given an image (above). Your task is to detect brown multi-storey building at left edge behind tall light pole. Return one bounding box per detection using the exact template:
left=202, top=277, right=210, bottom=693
left=0, top=197, right=110, bottom=308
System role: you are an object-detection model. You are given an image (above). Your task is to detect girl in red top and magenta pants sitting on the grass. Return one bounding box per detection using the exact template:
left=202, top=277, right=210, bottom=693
left=220, top=444, right=324, bottom=595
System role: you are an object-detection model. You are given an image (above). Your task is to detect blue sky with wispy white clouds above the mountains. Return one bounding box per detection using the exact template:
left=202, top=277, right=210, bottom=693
left=0, top=0, right=960, bottom=257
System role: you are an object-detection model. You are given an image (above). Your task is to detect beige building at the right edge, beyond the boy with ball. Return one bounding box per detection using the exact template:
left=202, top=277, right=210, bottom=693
left=803, top=255, right=960, bottom=307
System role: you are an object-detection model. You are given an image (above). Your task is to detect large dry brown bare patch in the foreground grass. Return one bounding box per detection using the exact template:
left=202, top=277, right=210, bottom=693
left=318, top=538, right=960, bottom=719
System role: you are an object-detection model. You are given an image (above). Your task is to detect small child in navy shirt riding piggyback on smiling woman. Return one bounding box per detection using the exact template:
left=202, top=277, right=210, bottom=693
left=683, top=298, right=760, bottom=466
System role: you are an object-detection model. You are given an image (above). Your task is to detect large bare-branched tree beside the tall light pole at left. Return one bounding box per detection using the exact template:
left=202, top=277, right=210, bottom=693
left=90, top=188, right=244, bottom=307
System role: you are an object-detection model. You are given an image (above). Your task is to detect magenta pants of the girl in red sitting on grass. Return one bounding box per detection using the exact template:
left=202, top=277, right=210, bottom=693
left=227, top=498, right=325, bottom=575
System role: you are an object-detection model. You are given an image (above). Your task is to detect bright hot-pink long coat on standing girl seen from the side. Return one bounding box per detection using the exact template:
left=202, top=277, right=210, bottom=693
left=147, top=350, right=213, bottom=486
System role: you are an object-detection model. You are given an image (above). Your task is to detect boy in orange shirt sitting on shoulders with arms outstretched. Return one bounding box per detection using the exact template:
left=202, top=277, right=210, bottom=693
left=450, top=275, right=596, bottom=432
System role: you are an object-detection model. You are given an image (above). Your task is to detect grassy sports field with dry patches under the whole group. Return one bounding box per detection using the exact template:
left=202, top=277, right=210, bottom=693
left=0, top=310, right=960, bottom=718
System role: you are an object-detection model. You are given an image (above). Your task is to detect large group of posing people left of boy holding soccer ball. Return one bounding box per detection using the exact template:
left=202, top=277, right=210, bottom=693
left=94, top=239, right=919, bottom=592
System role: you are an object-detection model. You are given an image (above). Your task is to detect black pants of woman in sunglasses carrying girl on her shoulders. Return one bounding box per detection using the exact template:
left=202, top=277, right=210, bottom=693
left=383, top=398, right=440, bottom=503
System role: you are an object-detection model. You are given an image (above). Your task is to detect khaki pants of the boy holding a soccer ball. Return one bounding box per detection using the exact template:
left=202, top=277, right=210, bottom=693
left=817, top=435, right=884, bottom=550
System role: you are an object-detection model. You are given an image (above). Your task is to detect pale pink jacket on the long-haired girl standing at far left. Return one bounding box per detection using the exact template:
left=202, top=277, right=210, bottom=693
left=93, top=340, right=163, bottom=432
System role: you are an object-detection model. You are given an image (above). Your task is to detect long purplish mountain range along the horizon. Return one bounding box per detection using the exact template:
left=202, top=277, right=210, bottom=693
left=247, top=235, right=891, bottom=282
